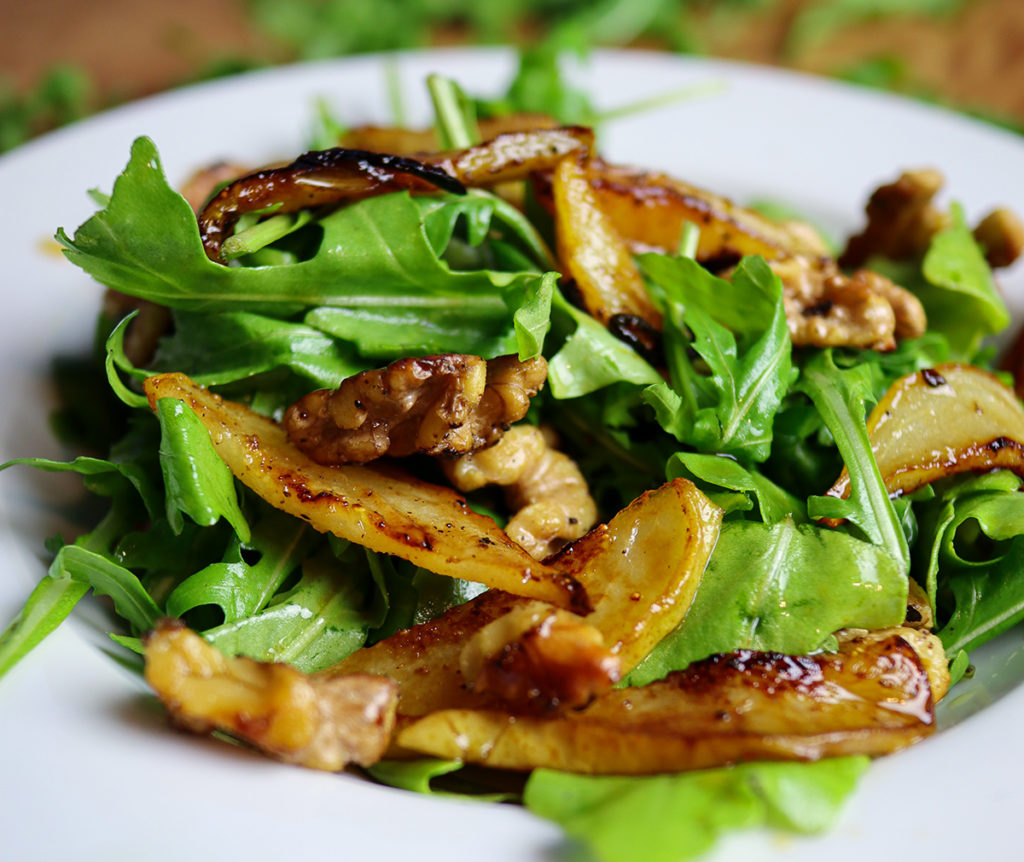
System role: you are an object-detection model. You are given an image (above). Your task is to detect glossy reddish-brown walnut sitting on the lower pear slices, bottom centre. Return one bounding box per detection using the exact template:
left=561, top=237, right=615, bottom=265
left=459, top=601, right=620, bottom=713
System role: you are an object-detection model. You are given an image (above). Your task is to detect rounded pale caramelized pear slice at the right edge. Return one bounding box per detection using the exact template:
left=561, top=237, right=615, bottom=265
left=827, top=362, right=1024, bottom=497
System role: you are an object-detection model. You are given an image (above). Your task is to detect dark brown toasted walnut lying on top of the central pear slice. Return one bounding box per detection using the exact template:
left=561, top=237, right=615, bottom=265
left=285, top=353, right=548, bottom=464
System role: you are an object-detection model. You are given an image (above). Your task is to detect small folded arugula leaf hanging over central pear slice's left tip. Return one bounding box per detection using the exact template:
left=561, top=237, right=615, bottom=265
left=156, top=398, right=249, bottom=541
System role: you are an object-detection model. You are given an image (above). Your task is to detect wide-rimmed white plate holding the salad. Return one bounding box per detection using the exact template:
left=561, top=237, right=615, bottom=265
left=0, top=50, right=1024, bottom=862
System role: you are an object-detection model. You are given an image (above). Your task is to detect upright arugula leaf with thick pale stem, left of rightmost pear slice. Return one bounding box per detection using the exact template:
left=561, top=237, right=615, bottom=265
left=797, top=350, right=910, bottom=571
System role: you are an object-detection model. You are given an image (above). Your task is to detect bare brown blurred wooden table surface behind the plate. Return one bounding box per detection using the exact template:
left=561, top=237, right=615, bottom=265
left=6, top=0, right=1024, bottom=123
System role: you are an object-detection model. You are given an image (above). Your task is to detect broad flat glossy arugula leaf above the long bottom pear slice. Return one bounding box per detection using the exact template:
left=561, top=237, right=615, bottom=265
left=628, top=509, right=907, bottom=685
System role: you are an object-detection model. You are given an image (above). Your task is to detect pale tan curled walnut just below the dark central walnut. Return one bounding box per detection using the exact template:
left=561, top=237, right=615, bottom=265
left=444, top=425, right=597, bottom=560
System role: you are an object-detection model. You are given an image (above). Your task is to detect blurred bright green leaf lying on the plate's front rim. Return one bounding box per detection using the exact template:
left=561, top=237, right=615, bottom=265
left=523, top=757, right=869, bottom=862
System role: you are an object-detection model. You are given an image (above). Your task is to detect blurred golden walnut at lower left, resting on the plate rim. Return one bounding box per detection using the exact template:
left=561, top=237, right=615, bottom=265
left=145, top=620, right=398, bottom=771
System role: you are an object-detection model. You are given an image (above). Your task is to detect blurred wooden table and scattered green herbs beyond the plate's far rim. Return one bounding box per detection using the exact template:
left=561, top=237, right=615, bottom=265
left=0, top=0, right=1024, bottom=150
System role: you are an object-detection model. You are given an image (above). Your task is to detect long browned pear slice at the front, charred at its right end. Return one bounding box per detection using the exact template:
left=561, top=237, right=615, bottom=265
left=396, top=630, right=944, bottom=775
